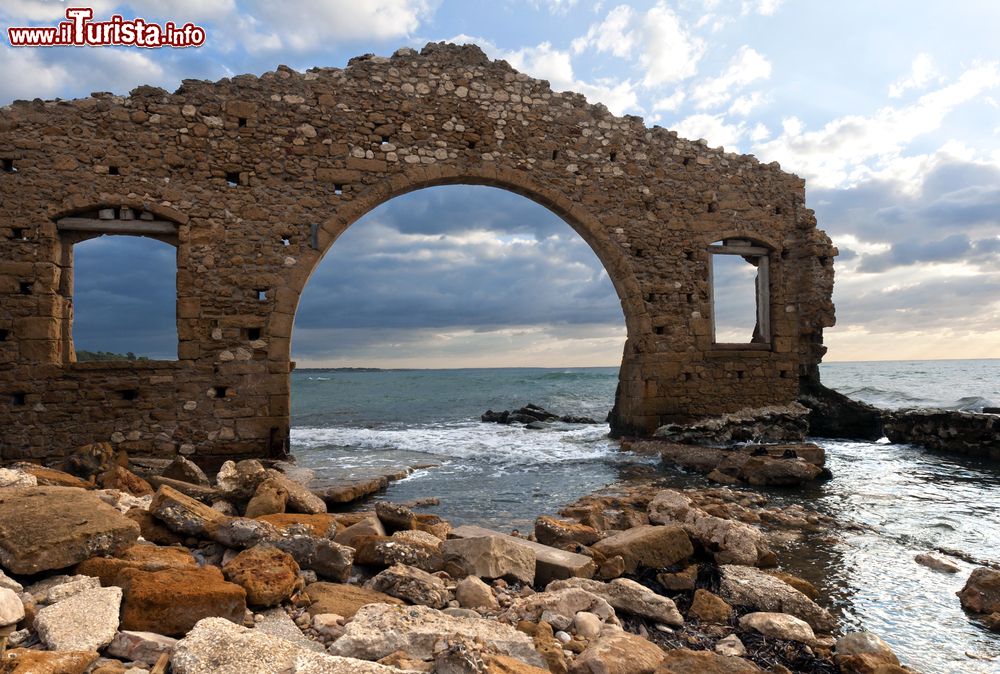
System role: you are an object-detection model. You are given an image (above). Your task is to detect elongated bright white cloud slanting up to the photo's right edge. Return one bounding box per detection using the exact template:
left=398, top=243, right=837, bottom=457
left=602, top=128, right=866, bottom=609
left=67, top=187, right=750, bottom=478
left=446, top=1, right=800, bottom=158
left=755, top=62, right=1000, bottom=187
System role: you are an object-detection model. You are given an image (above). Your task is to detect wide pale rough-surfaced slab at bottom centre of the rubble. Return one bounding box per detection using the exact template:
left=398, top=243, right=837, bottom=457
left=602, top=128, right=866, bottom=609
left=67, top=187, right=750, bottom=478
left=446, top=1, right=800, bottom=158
left=329, top=604, right=542, bottom=666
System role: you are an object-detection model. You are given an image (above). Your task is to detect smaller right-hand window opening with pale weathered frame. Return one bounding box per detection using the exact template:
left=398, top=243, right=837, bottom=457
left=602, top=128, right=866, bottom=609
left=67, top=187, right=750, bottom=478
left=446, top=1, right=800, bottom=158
left=709, top=239, right=771, bottom=346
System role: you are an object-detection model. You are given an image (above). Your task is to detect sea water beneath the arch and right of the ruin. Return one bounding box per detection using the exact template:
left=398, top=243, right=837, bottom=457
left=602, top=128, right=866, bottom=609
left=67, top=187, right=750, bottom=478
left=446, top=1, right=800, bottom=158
left=291, top=359, right=1000, bottom=674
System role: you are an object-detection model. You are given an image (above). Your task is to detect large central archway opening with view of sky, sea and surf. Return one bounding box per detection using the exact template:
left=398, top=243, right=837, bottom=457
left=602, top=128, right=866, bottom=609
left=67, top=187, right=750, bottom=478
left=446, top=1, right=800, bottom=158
left=291, top=185, right=626, bottom=526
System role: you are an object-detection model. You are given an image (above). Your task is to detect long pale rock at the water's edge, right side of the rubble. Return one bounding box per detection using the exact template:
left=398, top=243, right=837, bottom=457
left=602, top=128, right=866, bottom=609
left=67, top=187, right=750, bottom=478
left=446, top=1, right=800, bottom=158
left=649, top=489, right=774, bottom=566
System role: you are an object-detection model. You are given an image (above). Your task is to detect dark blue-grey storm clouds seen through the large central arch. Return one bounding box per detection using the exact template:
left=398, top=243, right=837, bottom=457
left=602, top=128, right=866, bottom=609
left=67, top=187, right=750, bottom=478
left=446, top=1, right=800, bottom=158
left=296, top=186, right=624, bottom=329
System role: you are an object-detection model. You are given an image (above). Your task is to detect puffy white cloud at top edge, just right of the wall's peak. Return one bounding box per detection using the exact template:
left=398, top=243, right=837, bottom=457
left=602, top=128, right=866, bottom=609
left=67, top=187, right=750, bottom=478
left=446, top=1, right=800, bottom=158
left=572, top=0, right=706, bottom=87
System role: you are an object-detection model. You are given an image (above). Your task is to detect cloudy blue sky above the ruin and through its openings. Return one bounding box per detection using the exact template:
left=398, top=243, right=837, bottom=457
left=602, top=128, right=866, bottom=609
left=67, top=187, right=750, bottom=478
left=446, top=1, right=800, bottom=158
left=0, top=0, right=1000, bottom=367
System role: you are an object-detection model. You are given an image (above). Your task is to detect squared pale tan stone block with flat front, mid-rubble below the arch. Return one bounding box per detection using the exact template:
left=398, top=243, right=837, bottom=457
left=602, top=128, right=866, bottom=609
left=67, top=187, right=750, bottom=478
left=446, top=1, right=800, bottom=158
left=442, top=536, right=535, bottom=585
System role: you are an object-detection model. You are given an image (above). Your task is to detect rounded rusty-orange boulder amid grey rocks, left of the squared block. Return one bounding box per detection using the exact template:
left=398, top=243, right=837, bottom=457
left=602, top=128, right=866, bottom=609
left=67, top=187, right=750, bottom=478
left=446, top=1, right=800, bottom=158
left=222, top=545, right=302, bottom=606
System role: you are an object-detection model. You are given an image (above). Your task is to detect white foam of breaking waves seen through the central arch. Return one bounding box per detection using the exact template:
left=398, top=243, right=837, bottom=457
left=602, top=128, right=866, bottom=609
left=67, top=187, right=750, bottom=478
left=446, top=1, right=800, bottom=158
left=291, top=422, right=617, bottom=465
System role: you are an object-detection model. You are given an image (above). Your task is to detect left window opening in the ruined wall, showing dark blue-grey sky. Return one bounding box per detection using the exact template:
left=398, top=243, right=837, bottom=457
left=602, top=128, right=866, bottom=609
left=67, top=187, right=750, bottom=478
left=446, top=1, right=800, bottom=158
left=70, top=235, right=177, bottom=362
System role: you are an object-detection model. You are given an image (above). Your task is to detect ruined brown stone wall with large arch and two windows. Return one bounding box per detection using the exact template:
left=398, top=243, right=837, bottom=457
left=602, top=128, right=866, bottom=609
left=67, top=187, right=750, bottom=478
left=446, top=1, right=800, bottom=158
left=0, top=45, right=836, bottom=461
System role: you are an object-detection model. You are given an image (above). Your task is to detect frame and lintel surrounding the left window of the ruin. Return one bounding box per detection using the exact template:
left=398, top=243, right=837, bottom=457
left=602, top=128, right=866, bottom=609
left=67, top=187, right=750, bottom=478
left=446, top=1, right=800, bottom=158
left=54, top=204, right=180, bottom=369
